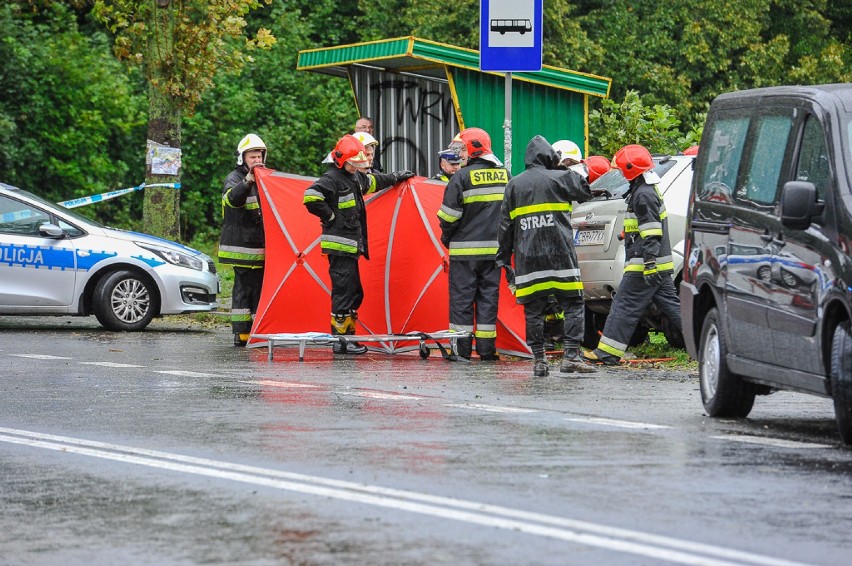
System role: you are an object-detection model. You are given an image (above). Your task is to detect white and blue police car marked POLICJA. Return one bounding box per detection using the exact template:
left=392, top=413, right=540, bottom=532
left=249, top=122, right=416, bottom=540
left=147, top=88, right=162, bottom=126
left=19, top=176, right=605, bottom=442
left=0, top=183, right=219, bottom=331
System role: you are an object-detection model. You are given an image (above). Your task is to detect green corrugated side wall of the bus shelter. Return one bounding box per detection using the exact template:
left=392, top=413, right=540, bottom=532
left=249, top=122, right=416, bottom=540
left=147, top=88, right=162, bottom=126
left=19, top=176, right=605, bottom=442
left=453, top=69, right=586, bottom=175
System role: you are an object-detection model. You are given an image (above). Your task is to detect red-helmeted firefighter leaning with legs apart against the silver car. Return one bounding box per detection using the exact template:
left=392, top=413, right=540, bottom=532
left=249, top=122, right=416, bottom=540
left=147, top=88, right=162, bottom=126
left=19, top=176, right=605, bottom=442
left=586, top=145, right=681, bottom=365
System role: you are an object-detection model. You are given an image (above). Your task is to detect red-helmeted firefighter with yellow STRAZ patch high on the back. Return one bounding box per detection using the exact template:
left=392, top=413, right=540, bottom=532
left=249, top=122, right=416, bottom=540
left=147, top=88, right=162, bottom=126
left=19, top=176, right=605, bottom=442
left=438, top=128, right=509, bottom=360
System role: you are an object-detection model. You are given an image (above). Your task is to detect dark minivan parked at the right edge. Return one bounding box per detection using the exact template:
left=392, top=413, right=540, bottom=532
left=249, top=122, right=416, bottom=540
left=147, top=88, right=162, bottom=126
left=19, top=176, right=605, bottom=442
left=680, top=83, right=852, bottom=444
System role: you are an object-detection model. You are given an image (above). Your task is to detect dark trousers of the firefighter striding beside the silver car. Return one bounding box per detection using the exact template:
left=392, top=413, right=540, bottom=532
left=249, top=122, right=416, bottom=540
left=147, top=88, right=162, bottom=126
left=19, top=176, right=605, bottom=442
left=598, top=273, right=682, bottom=358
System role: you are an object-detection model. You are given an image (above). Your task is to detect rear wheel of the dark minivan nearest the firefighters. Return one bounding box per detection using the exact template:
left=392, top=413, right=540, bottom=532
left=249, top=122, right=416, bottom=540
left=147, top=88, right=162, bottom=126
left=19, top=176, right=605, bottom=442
left=698, top=308, right=757, bottom=417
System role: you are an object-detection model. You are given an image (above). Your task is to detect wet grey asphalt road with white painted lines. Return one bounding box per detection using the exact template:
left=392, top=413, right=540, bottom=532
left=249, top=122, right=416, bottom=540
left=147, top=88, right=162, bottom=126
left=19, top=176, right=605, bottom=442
left=0, top=317, right=852, bottom=565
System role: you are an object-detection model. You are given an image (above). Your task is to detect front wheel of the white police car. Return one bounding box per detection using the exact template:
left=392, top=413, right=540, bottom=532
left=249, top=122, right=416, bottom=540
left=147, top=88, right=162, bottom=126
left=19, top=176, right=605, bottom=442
left=92, top=270, right=157, bottom=332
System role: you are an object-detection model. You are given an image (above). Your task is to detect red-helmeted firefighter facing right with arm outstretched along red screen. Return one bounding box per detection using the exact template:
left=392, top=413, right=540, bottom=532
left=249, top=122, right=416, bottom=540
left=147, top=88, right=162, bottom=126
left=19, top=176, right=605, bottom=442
left=303, top=134, right=414, bottom=354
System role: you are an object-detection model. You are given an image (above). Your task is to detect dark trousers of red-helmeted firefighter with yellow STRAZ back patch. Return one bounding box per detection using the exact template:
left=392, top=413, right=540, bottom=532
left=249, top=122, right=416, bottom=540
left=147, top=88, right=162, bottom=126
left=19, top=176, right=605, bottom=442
left=450, top=260, right=500, bottom=358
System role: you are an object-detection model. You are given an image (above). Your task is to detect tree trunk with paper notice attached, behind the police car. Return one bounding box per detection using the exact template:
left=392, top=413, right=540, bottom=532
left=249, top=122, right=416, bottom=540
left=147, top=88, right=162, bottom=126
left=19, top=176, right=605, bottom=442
left=142, top=3, right=181, bottom=240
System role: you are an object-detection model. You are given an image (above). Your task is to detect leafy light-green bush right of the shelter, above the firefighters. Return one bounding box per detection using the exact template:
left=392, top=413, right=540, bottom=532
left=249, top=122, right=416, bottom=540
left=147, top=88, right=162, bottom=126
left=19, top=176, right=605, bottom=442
left=589, top=90, right=703, bottom=156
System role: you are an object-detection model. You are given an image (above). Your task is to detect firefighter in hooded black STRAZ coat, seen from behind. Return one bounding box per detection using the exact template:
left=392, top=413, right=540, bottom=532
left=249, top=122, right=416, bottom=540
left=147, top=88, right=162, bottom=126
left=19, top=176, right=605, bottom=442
left=497, top=136, right=594, bottom=377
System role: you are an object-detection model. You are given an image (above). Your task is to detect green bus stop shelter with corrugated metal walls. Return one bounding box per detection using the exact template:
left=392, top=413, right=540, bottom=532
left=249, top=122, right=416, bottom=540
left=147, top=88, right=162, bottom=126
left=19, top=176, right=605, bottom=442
left=296, top=37, right=611, bottom=177
